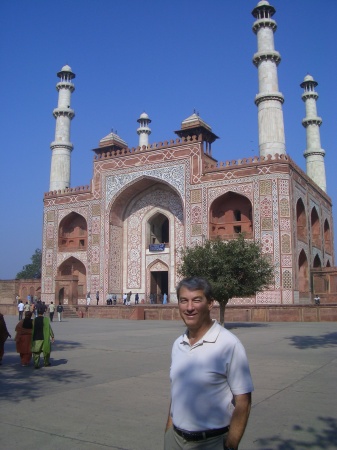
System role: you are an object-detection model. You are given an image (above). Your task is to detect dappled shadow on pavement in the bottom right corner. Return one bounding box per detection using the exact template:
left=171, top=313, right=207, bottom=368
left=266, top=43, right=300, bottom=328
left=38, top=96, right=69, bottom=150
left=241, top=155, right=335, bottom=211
left=256, top=417, right=337, bottom=450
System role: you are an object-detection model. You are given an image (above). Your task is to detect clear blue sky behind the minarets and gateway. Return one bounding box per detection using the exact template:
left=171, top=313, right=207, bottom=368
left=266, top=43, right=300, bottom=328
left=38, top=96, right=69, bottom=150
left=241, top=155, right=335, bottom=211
left=0, top=0, right=337, bottom=279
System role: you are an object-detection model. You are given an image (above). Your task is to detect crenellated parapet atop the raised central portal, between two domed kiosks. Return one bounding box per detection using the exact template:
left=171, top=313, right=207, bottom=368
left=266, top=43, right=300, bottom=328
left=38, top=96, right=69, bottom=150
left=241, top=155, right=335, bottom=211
left=94, top=135, right=202, bottom=161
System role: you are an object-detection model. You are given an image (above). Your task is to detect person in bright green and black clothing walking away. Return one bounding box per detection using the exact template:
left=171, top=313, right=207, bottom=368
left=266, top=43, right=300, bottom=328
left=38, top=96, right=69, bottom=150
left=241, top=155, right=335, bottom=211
left=32, top=308, right=54, bottom=369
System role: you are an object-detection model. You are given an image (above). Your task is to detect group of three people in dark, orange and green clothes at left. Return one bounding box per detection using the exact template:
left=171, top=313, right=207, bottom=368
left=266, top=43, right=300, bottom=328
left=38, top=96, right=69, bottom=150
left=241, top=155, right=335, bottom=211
left=0, top=306, right=54, bottom=369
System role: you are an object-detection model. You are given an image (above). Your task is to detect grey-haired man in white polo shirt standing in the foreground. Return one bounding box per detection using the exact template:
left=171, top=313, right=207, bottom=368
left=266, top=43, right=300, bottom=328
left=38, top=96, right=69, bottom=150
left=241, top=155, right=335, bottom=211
left=164, top=277, right=254, bottom=450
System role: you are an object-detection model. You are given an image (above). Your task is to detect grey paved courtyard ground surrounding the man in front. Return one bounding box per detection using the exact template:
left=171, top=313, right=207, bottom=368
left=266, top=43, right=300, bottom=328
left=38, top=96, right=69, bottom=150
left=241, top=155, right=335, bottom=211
left=0, top=316, right=337, bottom=450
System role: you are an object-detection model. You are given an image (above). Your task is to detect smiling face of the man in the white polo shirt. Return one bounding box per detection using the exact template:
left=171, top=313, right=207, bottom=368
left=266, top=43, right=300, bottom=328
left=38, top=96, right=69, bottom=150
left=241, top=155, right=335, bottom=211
left=179, top=286, right=213, bottom=331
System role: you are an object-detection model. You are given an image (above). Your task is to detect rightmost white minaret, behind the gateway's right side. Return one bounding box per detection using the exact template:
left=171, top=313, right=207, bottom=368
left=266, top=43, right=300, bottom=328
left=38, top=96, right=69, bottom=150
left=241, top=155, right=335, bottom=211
left=301, top=75, right=326, bottom=192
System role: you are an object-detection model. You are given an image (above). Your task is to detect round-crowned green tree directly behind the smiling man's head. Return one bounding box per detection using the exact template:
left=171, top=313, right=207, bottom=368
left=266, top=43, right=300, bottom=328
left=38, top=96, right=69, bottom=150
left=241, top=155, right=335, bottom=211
left=178, top=234, right=274, bottom=324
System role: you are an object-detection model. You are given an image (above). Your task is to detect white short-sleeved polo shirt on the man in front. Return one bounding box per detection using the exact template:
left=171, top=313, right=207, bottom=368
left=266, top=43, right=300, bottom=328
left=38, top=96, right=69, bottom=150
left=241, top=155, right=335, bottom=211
left=170, top=321, right=254, bottom=431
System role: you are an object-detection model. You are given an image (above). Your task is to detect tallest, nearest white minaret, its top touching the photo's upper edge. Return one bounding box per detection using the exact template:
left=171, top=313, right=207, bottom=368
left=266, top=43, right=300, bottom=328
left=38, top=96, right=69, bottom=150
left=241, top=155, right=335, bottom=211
left=252, top=0, right=286, bottom=156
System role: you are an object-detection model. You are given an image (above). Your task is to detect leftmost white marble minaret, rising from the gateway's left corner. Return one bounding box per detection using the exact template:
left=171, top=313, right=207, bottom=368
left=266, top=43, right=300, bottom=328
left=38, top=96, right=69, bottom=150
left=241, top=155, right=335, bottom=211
left=49, top=66, right=75, bottom=191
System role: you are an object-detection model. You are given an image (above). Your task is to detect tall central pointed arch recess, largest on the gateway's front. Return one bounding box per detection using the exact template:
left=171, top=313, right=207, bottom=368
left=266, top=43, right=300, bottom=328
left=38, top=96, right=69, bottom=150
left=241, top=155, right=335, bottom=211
left=106, top=177, right=184, bottom=298
